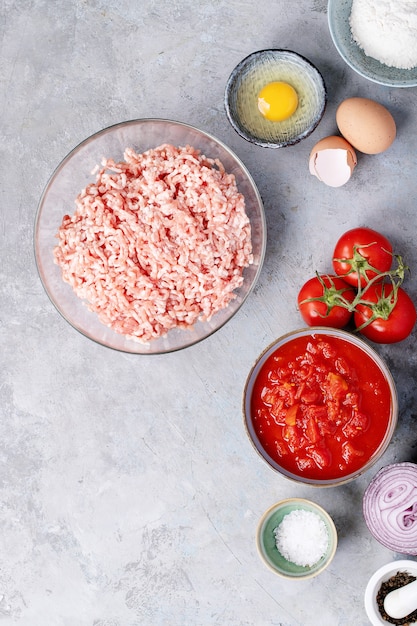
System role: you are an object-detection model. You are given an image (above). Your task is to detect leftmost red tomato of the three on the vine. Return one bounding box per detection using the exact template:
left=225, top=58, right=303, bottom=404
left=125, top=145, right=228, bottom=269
left=297, top=274, right=355, bottom=328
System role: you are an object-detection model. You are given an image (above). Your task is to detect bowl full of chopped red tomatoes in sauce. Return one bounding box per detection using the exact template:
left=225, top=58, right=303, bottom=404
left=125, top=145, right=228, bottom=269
left=243, top=327, right=398, bottom=487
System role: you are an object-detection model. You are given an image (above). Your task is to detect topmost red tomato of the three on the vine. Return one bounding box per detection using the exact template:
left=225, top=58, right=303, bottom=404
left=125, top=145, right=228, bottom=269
left=333, top=228, right=393, bottom=287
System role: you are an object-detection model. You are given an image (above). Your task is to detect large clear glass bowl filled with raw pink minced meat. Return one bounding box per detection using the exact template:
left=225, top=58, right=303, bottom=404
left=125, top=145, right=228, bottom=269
left=34, top=119, right=266, bottom=354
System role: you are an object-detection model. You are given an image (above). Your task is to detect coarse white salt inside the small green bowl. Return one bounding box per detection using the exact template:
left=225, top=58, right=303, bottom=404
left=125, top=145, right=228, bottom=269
left=274, top=509, right=329, bottom=567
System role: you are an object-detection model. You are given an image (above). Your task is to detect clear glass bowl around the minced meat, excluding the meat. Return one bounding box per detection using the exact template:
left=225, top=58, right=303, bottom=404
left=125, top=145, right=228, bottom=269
left=34, top=119, right=266, bottom=354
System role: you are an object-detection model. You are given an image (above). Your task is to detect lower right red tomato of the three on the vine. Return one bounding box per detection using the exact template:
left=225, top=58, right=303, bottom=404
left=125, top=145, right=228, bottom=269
left=354, top=284, right=417, bottom=343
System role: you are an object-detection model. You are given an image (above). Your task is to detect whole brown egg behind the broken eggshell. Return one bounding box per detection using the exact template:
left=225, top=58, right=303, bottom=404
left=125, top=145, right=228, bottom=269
left=336, top=98, right=396, bottom=154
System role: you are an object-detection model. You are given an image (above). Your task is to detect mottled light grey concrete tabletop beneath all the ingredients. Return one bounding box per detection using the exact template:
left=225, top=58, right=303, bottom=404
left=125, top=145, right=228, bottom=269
left=0, top=0, right=417, bottom=626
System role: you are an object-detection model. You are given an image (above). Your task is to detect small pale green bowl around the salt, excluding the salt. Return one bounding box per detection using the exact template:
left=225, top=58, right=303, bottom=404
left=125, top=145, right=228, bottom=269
left=256, top=498, right=337, bottom=580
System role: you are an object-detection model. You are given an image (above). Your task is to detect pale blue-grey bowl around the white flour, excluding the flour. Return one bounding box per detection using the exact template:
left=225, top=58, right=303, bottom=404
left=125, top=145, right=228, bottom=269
left=327, top=0, right=417, bottom=87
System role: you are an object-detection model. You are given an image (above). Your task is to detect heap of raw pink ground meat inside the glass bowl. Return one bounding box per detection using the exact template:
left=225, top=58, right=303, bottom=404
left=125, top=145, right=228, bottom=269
left=54, top=144, right=252, bottom=342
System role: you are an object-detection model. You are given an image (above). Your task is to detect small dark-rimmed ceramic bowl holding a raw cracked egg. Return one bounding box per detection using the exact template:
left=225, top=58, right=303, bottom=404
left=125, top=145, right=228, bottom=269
left=224, top=49, right=327, bottom=148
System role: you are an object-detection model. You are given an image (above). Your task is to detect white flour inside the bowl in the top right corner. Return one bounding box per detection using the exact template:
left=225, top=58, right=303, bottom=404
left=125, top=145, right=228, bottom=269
left=350, top=0, right=417, bottom=69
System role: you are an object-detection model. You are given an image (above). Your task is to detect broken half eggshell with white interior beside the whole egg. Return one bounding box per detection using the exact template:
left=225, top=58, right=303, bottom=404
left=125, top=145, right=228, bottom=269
left=309, top=135, right=357, bottom=187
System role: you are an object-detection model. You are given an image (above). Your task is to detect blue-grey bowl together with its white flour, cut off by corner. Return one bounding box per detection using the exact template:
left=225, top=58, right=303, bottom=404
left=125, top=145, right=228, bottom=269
left=328, top=0, right=417, bottom=87
